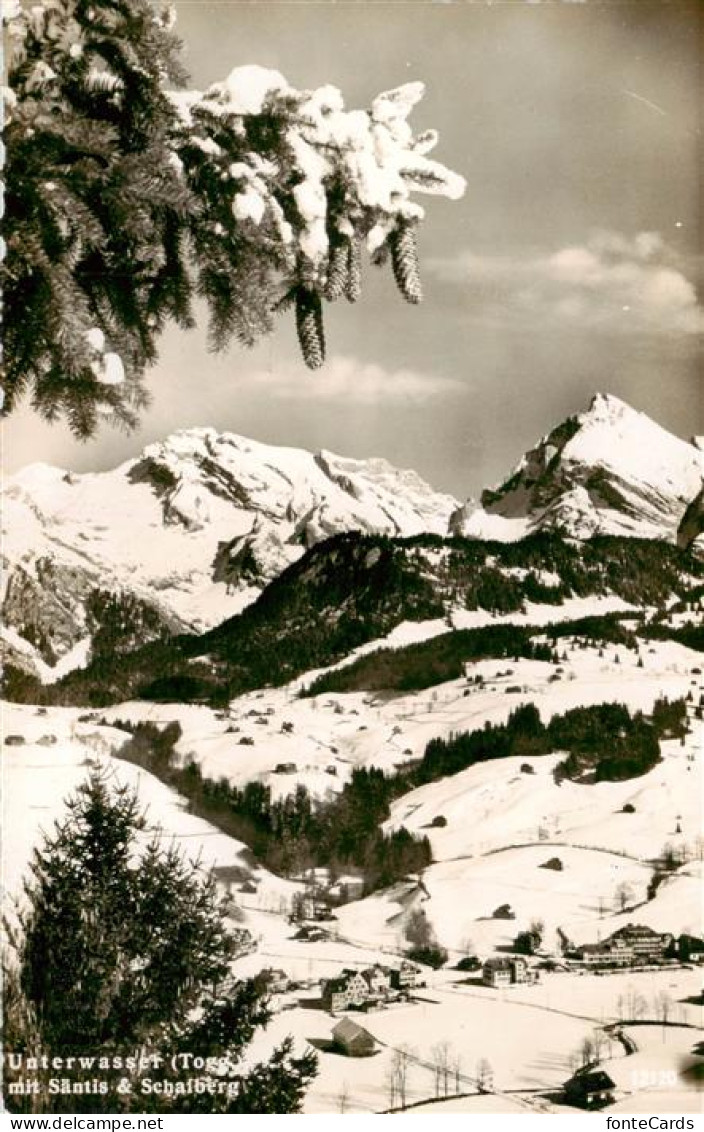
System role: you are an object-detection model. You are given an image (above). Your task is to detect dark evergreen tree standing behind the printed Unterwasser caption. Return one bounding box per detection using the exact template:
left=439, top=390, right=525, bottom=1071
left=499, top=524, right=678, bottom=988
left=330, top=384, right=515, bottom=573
left=3, top=773, right=316, bottom=1113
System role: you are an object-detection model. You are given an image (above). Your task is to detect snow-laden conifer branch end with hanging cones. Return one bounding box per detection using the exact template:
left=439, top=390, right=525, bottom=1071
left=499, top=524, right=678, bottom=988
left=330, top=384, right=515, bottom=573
left=170, top=66, right=465, bottom=368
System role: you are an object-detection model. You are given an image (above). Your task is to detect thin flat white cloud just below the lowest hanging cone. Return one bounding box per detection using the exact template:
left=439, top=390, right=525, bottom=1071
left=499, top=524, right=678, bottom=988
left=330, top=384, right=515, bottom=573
left=240, top=355, right=466, bottom=406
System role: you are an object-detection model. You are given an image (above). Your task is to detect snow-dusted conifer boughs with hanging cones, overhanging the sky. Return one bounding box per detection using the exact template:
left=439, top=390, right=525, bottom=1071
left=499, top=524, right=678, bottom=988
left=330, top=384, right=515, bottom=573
left=1, top=0, right=464, bottom=437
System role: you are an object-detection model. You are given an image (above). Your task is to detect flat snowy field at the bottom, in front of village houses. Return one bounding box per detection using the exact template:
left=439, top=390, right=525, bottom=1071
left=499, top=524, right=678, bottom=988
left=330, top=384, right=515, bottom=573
left=245, top=971, right=701, bottom=1114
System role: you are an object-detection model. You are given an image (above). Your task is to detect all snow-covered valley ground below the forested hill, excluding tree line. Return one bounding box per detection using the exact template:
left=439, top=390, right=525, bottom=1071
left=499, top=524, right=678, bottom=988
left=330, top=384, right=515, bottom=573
left=3, top=627, right=704, bottom=1113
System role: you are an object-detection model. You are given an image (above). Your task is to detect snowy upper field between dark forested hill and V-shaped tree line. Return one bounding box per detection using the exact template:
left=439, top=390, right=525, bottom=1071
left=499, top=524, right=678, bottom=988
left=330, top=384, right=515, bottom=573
left=95, top=633, right=701, bottom=810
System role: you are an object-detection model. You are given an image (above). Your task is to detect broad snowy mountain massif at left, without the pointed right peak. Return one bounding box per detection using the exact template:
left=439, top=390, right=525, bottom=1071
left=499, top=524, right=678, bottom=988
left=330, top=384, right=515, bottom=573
left=1, top=429, right=457, bottom=678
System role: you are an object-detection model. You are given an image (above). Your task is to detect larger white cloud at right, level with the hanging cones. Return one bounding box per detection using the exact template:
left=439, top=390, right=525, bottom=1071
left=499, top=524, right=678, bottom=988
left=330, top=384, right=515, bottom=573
left=427, top=232, right=704, bottom=336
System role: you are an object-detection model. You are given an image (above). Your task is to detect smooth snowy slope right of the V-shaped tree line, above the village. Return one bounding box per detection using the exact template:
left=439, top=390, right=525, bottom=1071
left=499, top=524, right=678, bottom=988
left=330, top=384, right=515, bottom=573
left=338, top=724, right=704, bottom=955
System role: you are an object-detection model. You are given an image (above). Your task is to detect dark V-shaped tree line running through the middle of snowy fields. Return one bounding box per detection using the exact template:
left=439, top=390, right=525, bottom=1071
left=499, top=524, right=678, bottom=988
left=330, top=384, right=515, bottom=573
left=115, top=700, right=687, bottom=893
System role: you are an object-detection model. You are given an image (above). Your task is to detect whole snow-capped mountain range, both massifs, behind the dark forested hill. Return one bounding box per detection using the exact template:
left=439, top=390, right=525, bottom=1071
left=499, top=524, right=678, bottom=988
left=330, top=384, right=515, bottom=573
left=1, top=395, right=704, bottom=680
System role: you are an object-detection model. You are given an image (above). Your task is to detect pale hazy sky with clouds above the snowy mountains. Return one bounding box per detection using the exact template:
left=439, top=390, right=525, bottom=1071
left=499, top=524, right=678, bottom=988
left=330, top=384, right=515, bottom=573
left=5, top=0, right=704, bottom=496
